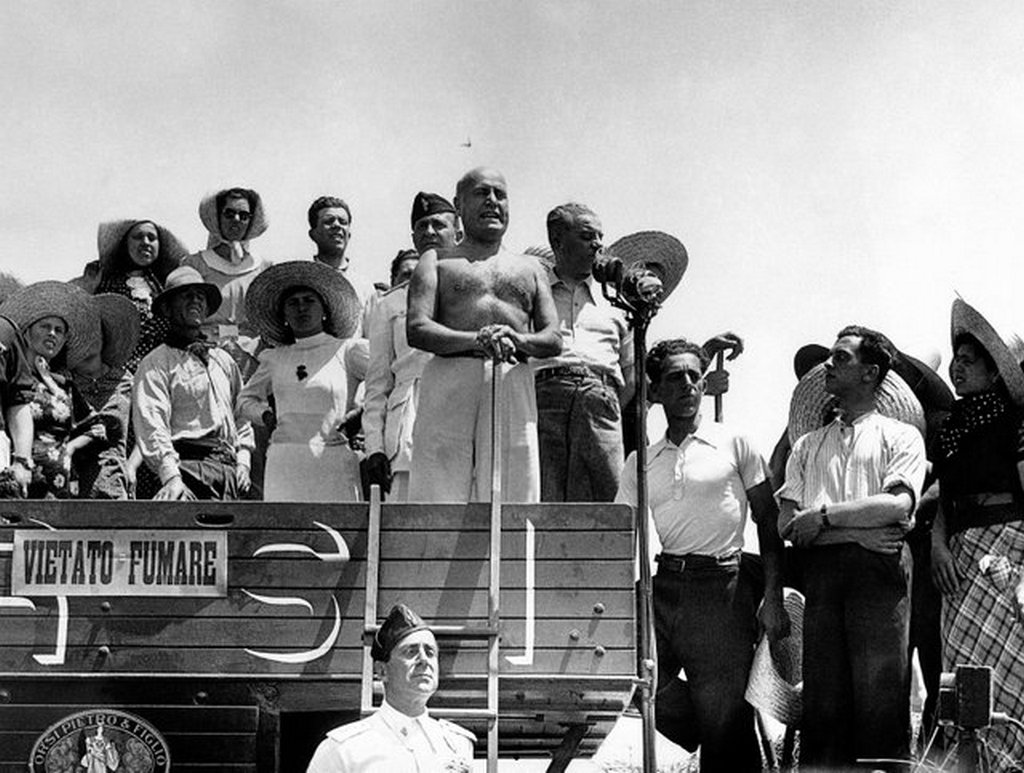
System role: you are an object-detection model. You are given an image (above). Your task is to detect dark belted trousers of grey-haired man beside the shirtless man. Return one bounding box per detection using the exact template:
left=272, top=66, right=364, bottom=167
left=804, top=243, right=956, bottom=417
left=537, top=376, right=624, bottom=502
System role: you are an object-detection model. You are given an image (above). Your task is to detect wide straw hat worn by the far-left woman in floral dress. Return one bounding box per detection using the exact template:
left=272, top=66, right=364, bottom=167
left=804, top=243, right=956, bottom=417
left=0, top=280, right=101, bottom=367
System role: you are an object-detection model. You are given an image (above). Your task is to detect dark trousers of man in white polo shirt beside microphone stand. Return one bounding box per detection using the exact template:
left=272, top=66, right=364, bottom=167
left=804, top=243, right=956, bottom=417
left=653, top=561, right=761, bottom=773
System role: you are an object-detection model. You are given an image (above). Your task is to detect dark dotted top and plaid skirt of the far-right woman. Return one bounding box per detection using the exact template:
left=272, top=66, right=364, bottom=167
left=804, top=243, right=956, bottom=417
left=936, top=392, right=1024, bottom=771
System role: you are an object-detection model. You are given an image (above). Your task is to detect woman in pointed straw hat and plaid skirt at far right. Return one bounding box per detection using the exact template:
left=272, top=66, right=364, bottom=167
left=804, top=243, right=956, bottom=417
left=932, top=299, right=1024, bottom=770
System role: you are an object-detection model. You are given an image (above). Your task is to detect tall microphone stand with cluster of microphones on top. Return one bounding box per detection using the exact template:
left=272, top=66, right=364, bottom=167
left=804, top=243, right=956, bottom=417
left=601, top=273, right=660, bottom=773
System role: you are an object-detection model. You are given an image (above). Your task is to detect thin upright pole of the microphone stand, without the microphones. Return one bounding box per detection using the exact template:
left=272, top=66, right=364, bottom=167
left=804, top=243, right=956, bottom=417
left=633, top=314, right=657, bottom=773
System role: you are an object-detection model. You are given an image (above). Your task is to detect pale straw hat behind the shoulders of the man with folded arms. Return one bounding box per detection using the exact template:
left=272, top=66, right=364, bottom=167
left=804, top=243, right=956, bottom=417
left=790, top=362, right=925, bottom=443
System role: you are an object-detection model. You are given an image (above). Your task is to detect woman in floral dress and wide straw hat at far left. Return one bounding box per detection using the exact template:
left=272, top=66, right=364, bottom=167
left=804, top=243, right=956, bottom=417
left=0, top=282, right=105, bottom=499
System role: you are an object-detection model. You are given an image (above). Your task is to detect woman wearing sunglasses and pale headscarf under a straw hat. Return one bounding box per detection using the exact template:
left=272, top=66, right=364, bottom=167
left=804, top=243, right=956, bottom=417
left=184, top=187, right=270, bottom=378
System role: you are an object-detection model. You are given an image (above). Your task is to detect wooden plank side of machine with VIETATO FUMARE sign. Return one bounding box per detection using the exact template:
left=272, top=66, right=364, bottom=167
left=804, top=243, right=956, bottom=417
left=0, top=502, right=636, bottom=771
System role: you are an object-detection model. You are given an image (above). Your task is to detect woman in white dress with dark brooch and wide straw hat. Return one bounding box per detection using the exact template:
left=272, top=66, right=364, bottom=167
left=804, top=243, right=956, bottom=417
left=239, top=260, right=369, bottom=502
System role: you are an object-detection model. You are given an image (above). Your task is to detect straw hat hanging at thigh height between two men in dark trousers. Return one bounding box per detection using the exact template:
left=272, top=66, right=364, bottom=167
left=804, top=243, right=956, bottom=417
left=744, top=588, right=804, bottom=727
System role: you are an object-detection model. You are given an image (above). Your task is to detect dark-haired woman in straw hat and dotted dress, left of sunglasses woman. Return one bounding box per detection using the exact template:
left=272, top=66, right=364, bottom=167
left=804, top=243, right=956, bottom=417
left=96, top=220, right=188, bottom=373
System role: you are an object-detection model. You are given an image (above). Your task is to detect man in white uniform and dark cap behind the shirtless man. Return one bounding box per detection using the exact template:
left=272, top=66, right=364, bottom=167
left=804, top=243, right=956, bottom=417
left=362, top=191, right=459, bottom=502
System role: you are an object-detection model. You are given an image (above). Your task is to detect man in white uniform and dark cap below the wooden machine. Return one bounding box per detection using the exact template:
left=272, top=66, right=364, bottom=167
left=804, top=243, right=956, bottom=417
left=306, top=604, right=476, bottom=773
